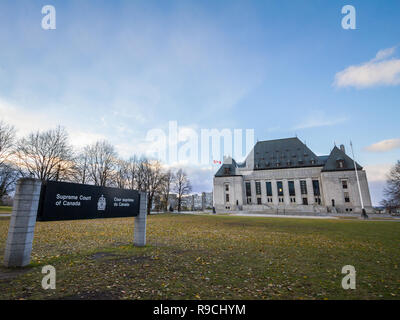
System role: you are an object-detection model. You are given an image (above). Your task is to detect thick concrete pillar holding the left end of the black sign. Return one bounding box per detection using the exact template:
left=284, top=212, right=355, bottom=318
left=4, top=178, right=42, bottom=267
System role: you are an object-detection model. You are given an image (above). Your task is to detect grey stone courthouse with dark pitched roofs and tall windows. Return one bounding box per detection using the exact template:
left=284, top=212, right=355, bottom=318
left=213, top=138, right=373, bottom=213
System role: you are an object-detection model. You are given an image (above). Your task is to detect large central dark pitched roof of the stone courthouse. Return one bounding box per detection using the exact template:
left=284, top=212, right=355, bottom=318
left=254, top=137, right=324, bottom=170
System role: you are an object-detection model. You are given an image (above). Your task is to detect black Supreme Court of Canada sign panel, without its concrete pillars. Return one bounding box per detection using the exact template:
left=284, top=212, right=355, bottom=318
left=37, top=181, right=139, bottom=221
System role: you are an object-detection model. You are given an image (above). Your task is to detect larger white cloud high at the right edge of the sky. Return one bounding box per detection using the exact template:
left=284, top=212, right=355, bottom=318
left=334, top=47, right=400, bottom=89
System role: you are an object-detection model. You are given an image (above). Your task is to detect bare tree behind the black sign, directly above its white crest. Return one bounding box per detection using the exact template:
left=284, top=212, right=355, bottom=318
left=84, top=141, right=117, bottom=187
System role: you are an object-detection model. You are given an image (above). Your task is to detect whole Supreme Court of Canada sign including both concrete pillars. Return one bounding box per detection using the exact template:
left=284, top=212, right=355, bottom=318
left=4, top=178, right=147, bottom=267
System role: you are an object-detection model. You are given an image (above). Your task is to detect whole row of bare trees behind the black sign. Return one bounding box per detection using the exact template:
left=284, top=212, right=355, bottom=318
left=0, top=121, right=192, bottom=214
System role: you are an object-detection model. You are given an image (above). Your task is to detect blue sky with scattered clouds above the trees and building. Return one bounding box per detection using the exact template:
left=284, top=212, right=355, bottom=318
left=0, top=0, right=400, bottom=205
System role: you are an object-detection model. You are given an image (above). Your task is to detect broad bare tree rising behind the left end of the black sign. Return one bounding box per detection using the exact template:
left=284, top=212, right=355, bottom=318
left=15, top=127, right=75, bottom=180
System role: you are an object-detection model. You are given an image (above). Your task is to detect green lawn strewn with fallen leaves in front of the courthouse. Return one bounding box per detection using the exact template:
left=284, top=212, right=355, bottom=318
left=0, top=215, right=400, bottom=299
